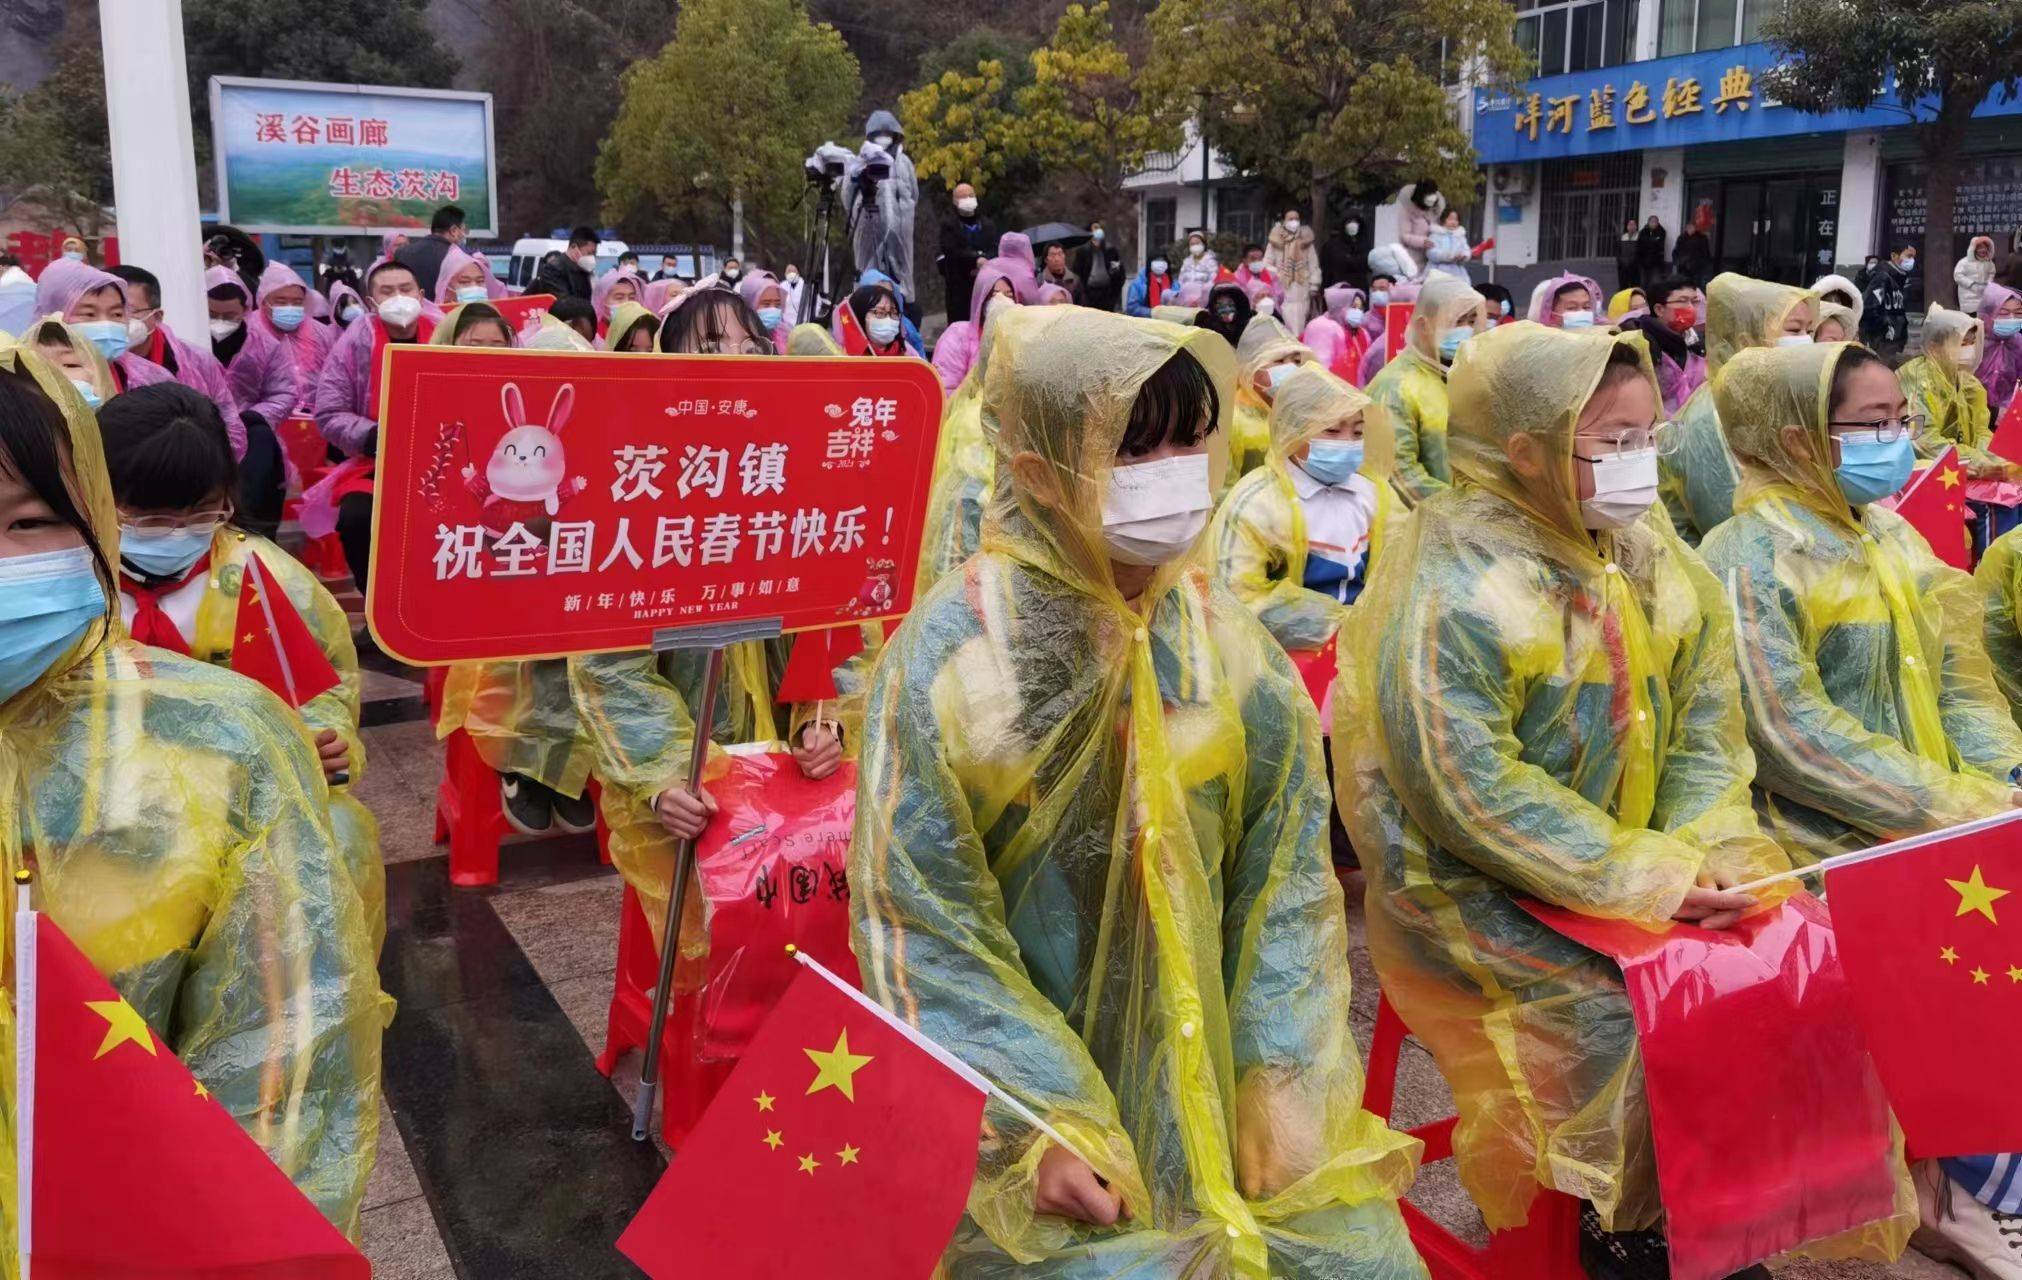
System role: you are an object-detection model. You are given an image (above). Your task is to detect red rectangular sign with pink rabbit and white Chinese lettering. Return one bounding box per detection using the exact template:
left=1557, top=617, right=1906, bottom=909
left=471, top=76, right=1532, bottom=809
left=366, top=346, right=940, bottom=665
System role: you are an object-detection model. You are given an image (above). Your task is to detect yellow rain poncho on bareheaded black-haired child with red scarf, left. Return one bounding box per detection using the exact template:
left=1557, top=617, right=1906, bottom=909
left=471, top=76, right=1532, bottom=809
left=190, top=528, right=390, bottom=954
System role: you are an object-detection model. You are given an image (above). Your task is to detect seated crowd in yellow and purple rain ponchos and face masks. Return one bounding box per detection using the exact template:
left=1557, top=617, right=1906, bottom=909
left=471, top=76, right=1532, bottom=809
left=19, top=181, right=2022, bottom=1280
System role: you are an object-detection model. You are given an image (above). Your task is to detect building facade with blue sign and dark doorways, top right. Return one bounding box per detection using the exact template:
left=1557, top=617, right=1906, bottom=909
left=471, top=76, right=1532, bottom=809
left=1464, top=0, right=2022, bottom=297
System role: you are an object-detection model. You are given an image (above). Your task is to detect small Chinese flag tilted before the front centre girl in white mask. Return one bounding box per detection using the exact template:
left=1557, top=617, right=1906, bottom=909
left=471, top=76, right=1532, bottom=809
left=619, top=954, right=985, bottom=1280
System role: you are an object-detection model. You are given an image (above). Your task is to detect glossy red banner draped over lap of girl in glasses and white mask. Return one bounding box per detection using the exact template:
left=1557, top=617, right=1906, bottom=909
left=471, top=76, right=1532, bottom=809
left=1525, top=894, right=1895, bottom=1280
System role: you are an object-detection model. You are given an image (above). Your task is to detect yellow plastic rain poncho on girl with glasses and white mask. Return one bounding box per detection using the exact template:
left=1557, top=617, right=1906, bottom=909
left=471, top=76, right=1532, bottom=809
left=1335, top=322, right=1787, bottom=1231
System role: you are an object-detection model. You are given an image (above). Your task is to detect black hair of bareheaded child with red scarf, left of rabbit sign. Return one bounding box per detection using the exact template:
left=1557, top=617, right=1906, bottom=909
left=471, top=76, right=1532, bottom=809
left=99, top=382, right=239, bottom=512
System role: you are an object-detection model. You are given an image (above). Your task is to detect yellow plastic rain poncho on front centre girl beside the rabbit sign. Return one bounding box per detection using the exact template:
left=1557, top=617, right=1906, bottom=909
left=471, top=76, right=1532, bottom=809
left=849, top=307, right=1423, bottom=1280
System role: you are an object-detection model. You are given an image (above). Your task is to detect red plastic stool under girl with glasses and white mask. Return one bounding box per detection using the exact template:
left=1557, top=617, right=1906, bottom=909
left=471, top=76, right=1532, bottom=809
left=1363, top=997, right=1585, bottom=1280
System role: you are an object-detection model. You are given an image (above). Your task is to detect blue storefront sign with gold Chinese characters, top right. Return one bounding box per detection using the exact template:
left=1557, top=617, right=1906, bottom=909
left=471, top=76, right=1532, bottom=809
left=1474, top=44, right=2022, bottom=164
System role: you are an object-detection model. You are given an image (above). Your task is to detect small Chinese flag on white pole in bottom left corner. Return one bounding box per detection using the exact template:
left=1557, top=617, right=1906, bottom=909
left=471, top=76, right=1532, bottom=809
left=14, top=912, right=372, bottom=1280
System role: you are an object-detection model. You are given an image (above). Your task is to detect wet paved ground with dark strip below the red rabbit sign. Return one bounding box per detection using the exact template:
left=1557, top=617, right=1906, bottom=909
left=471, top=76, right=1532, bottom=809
left=343, top=638, right=1961, bottom=1280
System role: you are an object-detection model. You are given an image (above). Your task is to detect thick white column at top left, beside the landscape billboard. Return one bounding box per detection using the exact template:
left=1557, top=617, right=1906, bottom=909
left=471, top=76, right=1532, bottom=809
left=99, top=0, right=210, bottom=340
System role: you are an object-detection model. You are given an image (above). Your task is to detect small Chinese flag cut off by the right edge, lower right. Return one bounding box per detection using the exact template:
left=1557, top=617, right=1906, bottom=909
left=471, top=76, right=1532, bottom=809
left=1826, top=813, right=2022, bottom=1159
